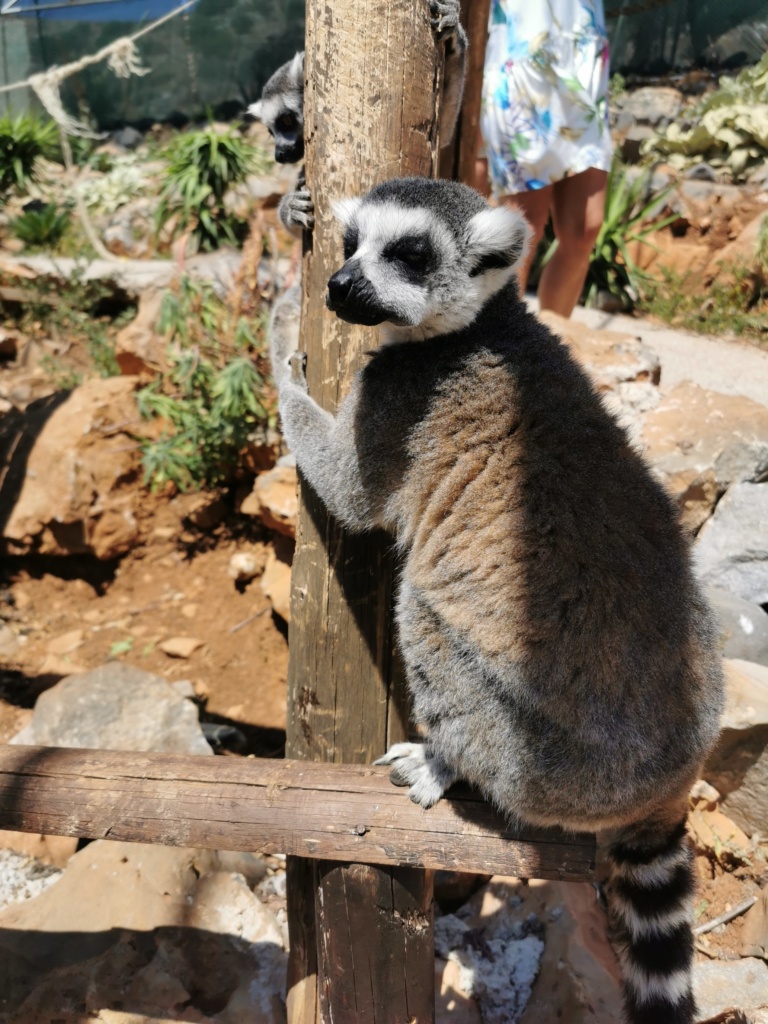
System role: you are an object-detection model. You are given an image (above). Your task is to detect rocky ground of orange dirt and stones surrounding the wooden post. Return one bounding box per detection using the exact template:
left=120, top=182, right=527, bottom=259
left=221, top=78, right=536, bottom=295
left=0, top=86, right=768, bottom=1024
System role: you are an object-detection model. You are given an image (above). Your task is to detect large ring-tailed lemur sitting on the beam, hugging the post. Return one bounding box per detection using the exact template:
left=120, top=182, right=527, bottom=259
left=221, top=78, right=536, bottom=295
left=271, top=178, right=722, bottom=1024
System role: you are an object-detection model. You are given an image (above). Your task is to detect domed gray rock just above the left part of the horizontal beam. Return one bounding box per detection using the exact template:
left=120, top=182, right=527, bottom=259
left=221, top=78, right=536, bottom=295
left=10, top=662, right=213, bottom=754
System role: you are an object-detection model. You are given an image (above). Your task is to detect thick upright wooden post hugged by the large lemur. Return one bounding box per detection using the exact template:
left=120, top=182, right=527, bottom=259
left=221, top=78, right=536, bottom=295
left=287, top=0, right=441, bottom=1024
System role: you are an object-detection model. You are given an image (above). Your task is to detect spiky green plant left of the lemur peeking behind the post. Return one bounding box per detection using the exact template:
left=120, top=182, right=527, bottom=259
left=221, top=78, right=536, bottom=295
left=155, top=125, right=269, bottom=249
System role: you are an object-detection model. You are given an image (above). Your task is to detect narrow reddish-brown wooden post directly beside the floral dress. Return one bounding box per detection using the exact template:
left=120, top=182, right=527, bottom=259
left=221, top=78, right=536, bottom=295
left=440, top=0, right=490, bottom=185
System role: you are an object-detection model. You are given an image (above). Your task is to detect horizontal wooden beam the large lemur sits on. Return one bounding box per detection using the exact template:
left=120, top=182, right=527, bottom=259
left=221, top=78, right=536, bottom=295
left=0, top=746, right=595, bottom=880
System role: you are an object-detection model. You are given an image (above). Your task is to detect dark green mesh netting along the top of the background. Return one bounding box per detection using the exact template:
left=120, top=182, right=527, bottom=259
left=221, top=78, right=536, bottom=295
left=0, top=0, right=768, bottom=129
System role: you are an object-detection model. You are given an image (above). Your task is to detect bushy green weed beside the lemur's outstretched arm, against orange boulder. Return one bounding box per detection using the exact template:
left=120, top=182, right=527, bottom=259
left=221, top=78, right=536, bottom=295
left=137, top=278, right=275, bottom=490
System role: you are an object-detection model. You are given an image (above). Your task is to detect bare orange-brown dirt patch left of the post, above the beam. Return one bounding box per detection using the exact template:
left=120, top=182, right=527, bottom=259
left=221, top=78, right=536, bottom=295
left=0, top=516, right=288, bottom=757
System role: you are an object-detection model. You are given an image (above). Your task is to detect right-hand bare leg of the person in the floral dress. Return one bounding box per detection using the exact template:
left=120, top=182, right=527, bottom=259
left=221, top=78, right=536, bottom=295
left=539, top=167, right=608, bottom=316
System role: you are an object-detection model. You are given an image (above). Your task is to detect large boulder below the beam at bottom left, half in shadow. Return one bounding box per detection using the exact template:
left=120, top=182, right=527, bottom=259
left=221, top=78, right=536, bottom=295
left=0, top=840, right=286, bottom=1024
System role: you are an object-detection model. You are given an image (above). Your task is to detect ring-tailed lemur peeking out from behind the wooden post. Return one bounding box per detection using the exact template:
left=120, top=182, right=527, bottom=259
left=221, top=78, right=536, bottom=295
left=248, top=0, right=467, bottom=237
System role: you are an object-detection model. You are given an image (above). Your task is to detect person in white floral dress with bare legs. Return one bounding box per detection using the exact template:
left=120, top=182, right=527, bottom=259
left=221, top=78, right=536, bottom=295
left=480, top=0, right=612, bottom=316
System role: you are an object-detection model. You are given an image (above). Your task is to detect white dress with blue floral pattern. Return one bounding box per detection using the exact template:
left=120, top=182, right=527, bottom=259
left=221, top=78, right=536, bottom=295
left=480, top=0, right=612, bottom=196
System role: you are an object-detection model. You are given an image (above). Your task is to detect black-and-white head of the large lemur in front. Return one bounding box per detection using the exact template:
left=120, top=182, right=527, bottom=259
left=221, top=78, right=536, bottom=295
left=326, top=178, right=530, bottom=340
